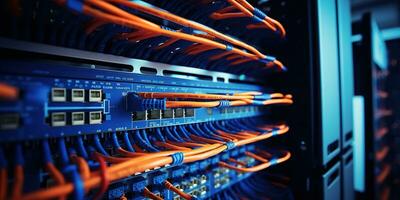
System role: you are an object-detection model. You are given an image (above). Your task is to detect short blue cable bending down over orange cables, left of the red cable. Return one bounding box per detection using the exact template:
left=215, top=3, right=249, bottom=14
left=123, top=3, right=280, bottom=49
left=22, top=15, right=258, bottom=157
left=63, top=165, right=85, bottom=200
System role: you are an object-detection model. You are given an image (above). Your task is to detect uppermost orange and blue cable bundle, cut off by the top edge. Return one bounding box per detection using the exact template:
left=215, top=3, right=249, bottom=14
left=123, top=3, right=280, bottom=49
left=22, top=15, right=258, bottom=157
left=146, top=0, right=286, bottom=44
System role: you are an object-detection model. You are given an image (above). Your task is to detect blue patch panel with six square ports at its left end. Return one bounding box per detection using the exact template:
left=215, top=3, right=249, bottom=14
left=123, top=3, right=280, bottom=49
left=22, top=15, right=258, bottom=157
left=0, top=61, right=278, bottom=141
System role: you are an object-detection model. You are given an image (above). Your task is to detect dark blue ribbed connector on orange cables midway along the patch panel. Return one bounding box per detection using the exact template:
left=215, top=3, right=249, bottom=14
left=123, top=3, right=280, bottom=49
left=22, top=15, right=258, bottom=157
left=126, top=92, right=167, bottom=112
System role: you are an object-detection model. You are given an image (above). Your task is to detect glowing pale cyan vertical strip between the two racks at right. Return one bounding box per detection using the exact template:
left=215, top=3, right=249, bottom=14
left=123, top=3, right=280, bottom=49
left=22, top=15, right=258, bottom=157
left=353, top=96, right=365, bottom=192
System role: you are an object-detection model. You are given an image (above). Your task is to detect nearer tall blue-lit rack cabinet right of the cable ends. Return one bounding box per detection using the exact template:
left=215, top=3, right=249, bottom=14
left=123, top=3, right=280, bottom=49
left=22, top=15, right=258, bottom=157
left=282, top=1, right=353, bottom=199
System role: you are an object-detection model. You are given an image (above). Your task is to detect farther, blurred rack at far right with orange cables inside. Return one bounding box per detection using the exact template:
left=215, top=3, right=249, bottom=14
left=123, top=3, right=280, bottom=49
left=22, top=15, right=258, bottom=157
left=353, top=13, right=392, bottom=199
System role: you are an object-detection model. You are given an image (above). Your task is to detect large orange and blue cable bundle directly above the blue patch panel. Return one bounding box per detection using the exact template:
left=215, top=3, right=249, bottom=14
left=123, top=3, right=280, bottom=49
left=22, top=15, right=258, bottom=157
left=1, top=0, right=286, bottom=76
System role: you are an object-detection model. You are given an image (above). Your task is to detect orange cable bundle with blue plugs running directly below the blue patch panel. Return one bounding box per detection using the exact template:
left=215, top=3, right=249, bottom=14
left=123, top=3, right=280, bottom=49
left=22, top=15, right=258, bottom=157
left=0, top=119, right=290, bottom=199
